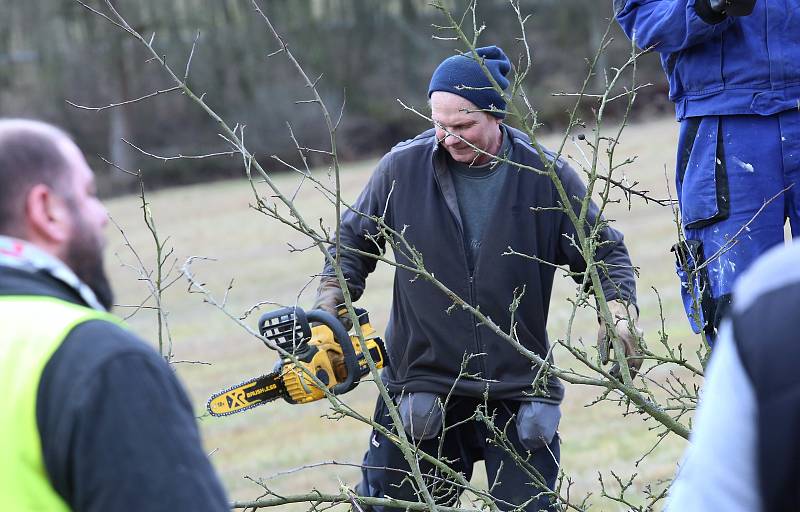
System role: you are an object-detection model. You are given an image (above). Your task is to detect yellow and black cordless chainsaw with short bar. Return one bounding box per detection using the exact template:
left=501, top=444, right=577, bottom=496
left=207, top=307, right=386, bottom=416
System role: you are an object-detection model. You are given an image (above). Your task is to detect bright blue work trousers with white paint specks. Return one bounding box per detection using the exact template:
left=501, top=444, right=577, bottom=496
left=673, top=110, right=800, bottom=341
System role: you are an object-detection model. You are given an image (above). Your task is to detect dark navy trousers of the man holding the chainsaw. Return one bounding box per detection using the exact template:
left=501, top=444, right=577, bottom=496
left=358, top=397, right=560, bottom=512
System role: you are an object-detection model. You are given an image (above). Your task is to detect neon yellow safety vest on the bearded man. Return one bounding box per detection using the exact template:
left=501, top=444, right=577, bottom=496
left=0, top=296, right=121, bottom=512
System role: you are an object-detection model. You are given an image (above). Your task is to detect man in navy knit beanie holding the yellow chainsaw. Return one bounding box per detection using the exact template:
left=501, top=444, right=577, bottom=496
left=315, top=46, right=641, bottom=511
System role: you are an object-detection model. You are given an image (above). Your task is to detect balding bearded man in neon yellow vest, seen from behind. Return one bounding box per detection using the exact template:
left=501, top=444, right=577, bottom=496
left=0, top=119, right=228, bottom=511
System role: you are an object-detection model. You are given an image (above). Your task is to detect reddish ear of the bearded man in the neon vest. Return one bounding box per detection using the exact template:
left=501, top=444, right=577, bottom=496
left=25, top=183, right=72, bottom=250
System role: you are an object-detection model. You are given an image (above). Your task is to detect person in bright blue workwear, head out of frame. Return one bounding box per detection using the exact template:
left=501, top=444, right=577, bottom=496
left=614, top=0, right=800, bottom=342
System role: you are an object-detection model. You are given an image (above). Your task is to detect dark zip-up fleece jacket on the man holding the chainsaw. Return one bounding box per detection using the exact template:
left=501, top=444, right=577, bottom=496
left=325, top=127, right=636, bottom=403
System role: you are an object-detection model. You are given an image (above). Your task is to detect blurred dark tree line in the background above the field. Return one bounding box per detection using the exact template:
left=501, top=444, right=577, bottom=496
left=0, top=0, right=669, bottom=194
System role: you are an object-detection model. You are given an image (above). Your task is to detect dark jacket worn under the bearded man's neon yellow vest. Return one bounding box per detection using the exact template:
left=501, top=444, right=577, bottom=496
left=0, top=267, right=229, bottom=512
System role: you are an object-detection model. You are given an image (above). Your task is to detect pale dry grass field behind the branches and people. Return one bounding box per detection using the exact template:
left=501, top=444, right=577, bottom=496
left=107, top=119, right=699, bottom=510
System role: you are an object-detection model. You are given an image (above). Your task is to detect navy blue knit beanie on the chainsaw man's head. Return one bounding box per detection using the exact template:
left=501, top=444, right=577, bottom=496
left=428, top=46, right=511, bottom=119
